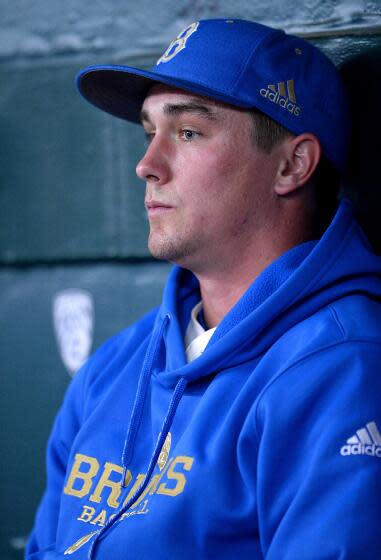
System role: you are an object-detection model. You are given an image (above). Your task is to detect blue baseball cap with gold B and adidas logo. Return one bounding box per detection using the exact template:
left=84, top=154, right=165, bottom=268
left=77, top=19, right=351, bottom=171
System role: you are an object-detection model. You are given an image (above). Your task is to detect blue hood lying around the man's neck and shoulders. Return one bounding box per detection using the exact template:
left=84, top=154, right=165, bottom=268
left=158, top=200, right=381, bottom=387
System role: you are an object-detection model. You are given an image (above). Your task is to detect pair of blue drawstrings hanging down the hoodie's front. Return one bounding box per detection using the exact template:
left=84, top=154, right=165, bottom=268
left=88, top=315, right=187, bottom=560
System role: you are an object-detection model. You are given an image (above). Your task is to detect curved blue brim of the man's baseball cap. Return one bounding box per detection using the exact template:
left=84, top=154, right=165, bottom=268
left=77, top=65, right=249, bottom=123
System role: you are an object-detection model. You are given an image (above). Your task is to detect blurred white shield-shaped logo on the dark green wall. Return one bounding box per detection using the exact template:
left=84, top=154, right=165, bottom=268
left=53, top=290, right=94, bottom=375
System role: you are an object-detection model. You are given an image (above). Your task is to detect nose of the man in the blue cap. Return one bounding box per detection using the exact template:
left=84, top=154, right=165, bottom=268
left=136, top=135, right=169, bottom=185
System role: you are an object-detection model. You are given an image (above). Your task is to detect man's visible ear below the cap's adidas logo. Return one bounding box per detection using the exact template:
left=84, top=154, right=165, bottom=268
left=275, top=132, right=322, bottom=196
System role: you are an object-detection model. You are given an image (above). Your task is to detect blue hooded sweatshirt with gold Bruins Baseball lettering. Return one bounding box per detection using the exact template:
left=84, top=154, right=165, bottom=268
left=27, top=201, right=381, bottom=560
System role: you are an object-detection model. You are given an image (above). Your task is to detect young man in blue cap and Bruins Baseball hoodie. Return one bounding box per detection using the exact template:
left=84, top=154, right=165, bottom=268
left=28, top=20, right=381, bottom=560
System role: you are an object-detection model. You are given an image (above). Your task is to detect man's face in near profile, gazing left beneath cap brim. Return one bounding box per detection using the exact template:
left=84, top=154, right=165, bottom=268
left=137, top=85, right=282, bottom=273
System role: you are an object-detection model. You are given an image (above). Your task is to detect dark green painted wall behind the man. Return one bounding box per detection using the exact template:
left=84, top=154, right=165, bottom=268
left=0, top=0, right=381, bottom=560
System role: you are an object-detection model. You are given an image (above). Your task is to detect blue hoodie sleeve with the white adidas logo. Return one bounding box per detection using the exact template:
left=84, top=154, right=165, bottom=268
left=257, top=340, right=381, bottom=560
